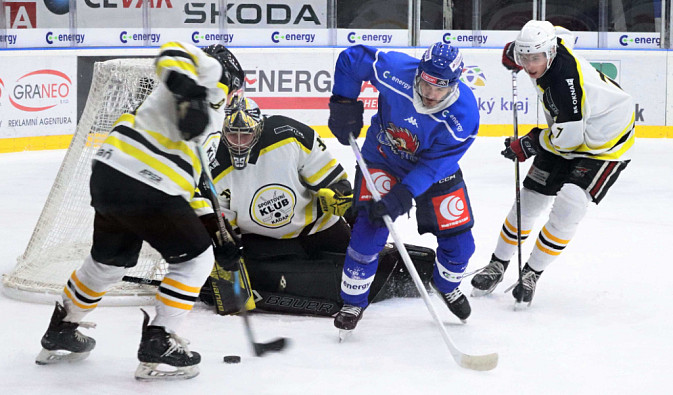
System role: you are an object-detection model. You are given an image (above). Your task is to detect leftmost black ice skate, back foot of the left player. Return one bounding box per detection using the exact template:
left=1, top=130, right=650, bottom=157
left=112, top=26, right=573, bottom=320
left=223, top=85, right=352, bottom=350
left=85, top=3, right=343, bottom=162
left=35, top=302, right=96, bottom=365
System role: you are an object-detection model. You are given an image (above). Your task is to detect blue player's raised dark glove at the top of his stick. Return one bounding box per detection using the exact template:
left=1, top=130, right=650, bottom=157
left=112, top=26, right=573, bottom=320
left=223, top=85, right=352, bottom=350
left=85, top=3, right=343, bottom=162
left=327, top=95, right=365, bottom=145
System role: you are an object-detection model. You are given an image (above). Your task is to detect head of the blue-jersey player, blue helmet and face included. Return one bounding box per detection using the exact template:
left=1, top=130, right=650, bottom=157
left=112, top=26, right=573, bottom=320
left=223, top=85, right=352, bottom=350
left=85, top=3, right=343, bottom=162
left=414, top=42, right=463, bottom=114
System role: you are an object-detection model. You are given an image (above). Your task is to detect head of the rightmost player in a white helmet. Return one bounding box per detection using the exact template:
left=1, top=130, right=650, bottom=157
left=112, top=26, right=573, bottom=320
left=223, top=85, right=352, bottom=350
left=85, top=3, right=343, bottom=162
left=514, top=20, right=557, bottom=78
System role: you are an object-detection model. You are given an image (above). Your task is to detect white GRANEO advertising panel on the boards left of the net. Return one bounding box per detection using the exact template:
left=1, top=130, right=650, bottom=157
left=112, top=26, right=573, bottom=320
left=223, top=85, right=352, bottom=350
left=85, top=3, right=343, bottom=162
left=0, top=56, right=77, bottom=138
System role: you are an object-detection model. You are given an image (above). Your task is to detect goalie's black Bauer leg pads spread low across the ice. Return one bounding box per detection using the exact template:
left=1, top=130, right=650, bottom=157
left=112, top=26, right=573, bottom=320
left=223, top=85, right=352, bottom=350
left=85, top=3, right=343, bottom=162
left=200, top=236, right=435, bottom=317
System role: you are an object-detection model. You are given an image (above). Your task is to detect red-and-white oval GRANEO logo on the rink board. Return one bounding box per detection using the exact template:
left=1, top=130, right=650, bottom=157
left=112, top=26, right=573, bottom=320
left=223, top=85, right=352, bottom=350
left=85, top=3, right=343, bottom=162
left=9, top=69, right=72, bottom=112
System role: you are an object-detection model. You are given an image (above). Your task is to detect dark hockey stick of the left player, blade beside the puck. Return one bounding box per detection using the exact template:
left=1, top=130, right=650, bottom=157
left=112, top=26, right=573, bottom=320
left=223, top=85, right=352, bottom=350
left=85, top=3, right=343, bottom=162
left=197, top=144, right=286, bottom=357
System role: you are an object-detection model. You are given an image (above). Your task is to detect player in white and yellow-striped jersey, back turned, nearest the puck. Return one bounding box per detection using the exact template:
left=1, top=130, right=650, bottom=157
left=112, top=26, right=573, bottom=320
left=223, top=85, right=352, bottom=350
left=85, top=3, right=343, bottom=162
left=36, top=42, right=244, bottom=380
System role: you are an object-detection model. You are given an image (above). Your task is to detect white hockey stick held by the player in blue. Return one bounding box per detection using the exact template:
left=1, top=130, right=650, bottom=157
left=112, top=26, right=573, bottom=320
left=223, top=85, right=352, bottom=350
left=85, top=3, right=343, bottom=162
left=348, top=135, right=498, bottom=370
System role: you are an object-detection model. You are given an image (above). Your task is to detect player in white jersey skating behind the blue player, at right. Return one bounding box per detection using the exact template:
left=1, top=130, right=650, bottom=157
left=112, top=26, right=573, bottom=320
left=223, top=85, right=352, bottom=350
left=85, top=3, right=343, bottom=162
left=472, top=20, right=635, bottom=306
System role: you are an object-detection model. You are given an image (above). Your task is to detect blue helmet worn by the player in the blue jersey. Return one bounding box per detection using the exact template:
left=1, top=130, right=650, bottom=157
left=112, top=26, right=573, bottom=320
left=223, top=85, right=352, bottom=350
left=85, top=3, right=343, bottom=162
left=416, top=42, right=463, bottom=87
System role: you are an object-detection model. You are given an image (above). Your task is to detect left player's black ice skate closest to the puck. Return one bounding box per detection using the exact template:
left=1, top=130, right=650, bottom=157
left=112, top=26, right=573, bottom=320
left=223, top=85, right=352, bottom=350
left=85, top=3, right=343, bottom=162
left=136, top=309, right=201, bottom=380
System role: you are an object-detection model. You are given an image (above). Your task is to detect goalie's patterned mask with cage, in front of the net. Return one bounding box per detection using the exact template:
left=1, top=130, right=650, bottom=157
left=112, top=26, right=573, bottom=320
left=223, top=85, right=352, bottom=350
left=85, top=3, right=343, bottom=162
left=222, top=98, right=264, bottom=170
